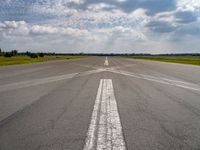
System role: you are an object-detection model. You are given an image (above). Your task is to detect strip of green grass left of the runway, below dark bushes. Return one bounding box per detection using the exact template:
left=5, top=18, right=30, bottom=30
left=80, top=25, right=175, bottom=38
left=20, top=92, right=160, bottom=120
left=0, top=55, right=88, bottom=66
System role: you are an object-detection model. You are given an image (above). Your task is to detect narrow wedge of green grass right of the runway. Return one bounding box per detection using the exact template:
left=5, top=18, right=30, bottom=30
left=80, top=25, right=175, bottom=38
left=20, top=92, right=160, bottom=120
left=128, top=56, right=200, bottom=65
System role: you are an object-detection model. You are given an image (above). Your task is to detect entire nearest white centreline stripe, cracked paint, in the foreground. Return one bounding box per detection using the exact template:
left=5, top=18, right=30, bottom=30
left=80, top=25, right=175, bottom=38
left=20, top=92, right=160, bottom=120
left=83, top=79, right=126, bottom=150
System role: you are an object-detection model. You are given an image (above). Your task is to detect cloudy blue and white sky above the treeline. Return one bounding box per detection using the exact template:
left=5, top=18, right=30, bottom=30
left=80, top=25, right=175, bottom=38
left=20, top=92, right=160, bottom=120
left=0, top=0, right=200, bottom=54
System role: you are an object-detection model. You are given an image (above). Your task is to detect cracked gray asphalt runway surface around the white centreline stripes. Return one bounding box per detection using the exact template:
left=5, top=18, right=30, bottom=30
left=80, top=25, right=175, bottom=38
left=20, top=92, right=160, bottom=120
left=0, top=57, right=200, bottom=150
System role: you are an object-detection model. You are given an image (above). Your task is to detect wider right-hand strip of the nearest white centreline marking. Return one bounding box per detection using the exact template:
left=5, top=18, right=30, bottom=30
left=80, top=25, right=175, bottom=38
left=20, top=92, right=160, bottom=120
left=96, top=79, right=126, bottom=150
